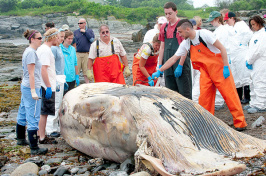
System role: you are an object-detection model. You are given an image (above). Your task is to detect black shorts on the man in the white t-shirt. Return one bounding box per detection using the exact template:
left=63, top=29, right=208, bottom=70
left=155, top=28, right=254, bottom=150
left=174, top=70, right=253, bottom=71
left=41, top=87, right=55, bottom=115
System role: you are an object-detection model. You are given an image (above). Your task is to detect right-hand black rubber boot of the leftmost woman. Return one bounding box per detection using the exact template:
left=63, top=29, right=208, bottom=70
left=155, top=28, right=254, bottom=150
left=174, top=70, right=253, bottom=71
left=28, top=130, right=48, bottom=155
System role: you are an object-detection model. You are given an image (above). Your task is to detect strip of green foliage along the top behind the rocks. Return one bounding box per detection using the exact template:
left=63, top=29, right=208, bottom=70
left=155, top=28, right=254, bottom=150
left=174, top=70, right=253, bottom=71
left=0, top=0, right=266, bottom=24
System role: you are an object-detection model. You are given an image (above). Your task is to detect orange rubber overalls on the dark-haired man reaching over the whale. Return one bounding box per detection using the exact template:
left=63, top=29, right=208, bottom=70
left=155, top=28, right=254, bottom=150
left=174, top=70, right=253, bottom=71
left=190, top=36, right=247, bottom=128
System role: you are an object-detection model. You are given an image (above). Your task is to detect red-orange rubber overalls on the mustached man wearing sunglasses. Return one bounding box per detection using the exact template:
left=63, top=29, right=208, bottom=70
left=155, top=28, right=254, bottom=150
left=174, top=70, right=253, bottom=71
left=93, top=40, right=126, bottom=84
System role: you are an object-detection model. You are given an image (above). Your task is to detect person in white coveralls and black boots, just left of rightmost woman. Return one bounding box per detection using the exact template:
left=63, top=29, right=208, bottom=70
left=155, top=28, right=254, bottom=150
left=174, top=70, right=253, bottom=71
left=224, top=12, right=252, bottom=104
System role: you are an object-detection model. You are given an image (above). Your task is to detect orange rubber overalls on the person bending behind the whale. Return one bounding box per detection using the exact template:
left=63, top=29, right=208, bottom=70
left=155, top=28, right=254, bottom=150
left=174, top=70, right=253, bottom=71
left=132, top=43, right=158, bottom=86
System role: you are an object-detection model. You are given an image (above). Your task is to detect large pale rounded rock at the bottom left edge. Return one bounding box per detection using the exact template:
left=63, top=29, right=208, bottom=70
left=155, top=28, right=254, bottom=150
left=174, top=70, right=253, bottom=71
left=10, top=163, right=39, bottom=176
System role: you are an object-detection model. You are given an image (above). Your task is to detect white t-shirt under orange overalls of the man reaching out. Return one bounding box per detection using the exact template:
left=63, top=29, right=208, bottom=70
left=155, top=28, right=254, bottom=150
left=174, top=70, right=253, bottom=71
left=175, top=29, right=221, bottom=56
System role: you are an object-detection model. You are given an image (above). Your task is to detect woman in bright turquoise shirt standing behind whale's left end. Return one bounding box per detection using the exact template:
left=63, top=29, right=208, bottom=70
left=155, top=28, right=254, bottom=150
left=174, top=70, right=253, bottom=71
left=60, top=31, right=79, bottom=94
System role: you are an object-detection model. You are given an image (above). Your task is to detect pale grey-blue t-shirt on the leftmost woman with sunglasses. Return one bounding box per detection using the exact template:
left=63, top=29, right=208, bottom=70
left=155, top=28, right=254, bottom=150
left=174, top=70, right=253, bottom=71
left=21, top=47, right=42, bottom=88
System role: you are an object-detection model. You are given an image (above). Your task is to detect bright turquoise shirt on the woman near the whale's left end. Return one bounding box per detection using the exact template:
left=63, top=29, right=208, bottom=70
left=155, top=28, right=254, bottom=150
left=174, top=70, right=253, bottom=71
left=60, top=44, right=78, bottom=82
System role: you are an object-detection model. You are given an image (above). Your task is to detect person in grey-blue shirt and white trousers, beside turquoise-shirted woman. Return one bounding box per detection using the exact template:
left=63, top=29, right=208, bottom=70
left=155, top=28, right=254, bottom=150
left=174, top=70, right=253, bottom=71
left=46, top=29, right=65, bottom=137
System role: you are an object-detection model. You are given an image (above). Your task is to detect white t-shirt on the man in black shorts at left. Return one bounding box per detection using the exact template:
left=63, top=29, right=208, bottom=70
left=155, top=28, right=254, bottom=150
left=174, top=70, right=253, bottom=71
left=36, top=44, right=56, bottom=92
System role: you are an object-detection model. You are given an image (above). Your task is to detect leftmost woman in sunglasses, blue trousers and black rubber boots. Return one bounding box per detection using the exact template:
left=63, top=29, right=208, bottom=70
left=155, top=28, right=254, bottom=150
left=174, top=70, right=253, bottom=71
left=16, top=30, right=48, bottom=155
